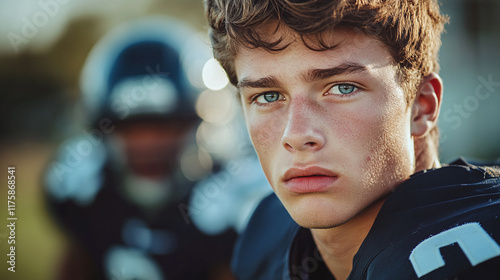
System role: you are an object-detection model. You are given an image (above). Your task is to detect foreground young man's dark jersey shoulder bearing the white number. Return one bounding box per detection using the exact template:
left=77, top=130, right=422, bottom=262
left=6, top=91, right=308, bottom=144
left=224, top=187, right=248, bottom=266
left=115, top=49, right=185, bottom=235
left=352, top=160, right=500, bottom=279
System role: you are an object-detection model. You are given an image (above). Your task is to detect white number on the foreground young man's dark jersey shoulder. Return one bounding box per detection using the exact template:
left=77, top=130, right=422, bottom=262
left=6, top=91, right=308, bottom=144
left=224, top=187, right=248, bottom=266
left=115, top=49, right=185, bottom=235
left=410, top=223, right=500, bottom=278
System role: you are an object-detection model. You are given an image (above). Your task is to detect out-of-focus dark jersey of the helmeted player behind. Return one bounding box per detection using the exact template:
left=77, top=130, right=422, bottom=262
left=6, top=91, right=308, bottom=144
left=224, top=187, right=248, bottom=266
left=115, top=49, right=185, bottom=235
left=47, top=139, right=236, bottom=280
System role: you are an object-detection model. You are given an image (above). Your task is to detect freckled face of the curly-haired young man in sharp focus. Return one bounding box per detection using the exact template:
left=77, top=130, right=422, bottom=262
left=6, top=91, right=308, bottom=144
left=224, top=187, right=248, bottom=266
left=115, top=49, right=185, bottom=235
left=235, top=27, right=415, bottom=228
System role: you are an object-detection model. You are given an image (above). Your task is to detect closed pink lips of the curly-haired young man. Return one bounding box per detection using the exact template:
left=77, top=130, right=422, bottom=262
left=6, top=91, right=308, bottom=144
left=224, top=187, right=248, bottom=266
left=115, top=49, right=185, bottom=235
left=282, top=166, right=338, bottom=193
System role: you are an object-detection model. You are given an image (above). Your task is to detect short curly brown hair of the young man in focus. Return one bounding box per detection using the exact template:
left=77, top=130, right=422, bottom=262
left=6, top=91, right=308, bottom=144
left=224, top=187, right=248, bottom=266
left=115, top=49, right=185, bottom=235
left=205, top=0, right=448, bottom=150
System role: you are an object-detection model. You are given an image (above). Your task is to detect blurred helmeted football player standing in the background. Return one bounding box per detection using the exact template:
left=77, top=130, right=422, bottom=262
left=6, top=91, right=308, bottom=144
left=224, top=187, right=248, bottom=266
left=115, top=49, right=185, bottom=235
left=46, top=19, right=235, bottom=280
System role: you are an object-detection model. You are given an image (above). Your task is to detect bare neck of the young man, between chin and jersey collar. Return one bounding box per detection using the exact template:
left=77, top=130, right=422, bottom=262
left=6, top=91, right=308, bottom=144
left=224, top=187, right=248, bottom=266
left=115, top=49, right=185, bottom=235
left=311, top=199, right=385, bottom=280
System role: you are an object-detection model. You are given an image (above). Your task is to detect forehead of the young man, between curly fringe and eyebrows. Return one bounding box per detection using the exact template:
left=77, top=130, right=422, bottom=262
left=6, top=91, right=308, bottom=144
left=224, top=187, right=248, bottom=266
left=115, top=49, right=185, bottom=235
left=234, top=24, right=396, bottom=80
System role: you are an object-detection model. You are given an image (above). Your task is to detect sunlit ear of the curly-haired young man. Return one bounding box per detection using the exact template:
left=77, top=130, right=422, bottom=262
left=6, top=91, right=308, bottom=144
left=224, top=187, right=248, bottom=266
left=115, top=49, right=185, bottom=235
left=411, top=72, right=443, bottom=137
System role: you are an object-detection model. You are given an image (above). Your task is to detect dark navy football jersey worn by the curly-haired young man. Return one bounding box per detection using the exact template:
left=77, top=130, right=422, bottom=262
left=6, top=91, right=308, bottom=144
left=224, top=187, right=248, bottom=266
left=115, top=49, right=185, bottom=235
left=232, top=160, right=500, bottom=280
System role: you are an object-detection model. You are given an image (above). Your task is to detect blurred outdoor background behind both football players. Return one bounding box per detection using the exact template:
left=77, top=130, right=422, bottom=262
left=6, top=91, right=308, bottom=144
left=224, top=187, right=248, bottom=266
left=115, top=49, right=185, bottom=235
left=0, top=0, right=500, bottom=280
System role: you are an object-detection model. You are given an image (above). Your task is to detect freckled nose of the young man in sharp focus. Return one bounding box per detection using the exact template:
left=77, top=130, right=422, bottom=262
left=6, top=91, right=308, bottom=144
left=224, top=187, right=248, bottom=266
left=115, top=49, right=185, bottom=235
left=281, top=99, right=326, bottom=152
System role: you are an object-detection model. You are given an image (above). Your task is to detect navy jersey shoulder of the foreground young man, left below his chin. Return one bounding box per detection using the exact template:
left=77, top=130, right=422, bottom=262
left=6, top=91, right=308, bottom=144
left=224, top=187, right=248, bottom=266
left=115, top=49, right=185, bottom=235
left=232, top=193, right=299, bottom=280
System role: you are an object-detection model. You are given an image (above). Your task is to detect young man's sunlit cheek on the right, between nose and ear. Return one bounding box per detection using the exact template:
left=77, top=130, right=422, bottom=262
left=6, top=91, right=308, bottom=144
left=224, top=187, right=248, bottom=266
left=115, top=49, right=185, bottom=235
left=335, top=94, right=411, bottom=188
